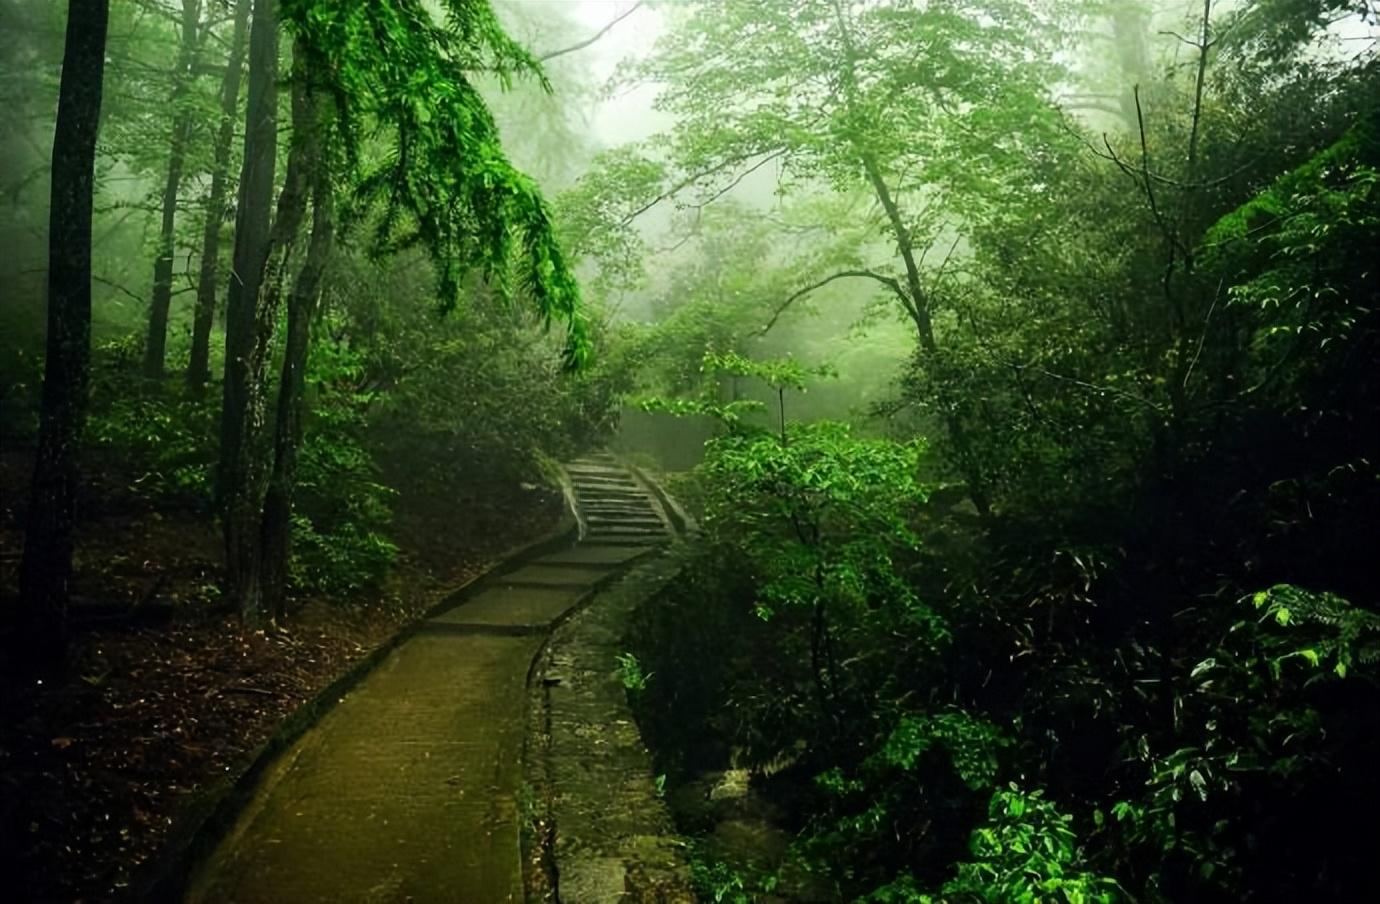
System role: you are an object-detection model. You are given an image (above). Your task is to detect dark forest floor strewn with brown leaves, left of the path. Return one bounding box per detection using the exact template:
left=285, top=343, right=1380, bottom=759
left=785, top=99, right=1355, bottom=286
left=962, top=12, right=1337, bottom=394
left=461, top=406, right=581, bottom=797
left=0, top=450, right=560, bottom=903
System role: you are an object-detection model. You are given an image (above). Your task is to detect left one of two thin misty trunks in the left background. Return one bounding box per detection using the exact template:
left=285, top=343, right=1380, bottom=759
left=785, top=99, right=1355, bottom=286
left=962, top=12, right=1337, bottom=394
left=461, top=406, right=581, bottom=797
left=144, top=0, right=201, bottom=380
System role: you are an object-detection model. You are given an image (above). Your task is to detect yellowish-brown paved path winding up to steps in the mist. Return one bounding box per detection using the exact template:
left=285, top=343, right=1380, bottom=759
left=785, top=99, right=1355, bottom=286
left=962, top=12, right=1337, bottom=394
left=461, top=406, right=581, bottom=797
left=186, top=455, right=671, bottom=904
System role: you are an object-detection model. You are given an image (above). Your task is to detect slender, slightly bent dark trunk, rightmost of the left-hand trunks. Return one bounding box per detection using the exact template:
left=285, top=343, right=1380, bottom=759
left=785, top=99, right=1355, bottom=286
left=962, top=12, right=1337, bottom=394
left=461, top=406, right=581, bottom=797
left=262, top=67, right=335, bottom=624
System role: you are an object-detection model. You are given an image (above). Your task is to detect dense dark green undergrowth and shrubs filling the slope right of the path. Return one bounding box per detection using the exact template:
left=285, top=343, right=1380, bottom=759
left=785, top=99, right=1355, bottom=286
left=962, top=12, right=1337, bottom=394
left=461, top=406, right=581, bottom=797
left=629, top=24, right=1380, bottom=903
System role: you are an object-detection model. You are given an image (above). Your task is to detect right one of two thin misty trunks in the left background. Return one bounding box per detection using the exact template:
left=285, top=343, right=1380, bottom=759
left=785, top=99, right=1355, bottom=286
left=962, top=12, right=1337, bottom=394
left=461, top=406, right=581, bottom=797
left=186, top=0, right=253, bottom=389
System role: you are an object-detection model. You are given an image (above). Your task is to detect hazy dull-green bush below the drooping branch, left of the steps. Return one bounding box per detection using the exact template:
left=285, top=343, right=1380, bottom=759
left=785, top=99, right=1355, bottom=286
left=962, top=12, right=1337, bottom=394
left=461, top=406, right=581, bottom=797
left=325, top=258, right=614, bottom=491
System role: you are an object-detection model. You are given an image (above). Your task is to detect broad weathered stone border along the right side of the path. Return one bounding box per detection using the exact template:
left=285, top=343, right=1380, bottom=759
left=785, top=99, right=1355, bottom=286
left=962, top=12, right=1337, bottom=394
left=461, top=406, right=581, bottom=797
left=522, top=543, right=694, bottom=904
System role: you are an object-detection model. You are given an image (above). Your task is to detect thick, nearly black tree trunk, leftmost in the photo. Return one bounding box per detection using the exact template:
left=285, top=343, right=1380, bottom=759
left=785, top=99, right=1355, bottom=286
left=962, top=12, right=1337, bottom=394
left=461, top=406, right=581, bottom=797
left=17, top=0, right=110, bottom=667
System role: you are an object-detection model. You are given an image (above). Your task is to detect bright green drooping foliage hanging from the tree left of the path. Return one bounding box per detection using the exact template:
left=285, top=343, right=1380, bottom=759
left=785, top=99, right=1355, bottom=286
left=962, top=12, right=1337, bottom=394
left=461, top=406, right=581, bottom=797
left=283, top=0, right=591, bottom=369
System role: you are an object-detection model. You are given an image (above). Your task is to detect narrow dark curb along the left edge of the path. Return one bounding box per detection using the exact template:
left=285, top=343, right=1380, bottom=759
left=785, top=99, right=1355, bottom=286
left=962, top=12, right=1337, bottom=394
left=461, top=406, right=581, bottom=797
left=123, top=485, right=580, bottom=904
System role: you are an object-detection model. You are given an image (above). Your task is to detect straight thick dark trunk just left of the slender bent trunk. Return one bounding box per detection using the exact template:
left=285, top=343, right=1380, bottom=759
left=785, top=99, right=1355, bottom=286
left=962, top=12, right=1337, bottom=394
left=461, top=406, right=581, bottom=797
left=217, top=0, right=277, bottom=624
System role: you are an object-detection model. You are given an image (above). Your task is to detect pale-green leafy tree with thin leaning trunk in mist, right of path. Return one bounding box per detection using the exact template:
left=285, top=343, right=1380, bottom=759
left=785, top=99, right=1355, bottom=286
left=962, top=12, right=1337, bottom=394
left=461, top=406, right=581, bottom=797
left=626, top=0, right=1057, bottom=512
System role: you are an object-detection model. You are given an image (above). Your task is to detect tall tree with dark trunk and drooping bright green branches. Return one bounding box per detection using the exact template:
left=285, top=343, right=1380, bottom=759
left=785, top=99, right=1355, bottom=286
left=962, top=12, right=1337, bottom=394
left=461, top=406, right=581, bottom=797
left=221, top=0, right=588, bottom=624
